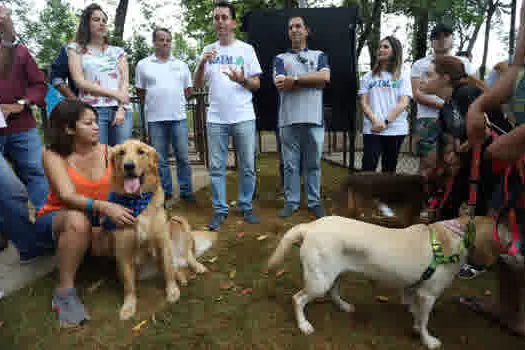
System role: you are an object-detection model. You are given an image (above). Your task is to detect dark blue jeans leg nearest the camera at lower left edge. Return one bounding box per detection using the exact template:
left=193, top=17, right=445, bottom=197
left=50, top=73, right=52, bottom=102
left=0, top=155, right=53, bottom=257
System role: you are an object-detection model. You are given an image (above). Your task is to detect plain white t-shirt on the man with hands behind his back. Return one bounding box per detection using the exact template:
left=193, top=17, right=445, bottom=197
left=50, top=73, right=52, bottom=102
left=135, top=55, right=192, bottom=122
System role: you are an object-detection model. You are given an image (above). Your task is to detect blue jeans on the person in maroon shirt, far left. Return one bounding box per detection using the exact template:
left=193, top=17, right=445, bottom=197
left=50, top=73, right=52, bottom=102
left=0, top=128, right=49, bottom=211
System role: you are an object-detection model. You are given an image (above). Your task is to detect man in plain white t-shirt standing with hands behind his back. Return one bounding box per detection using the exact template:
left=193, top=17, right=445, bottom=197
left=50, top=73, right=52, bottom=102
left=135, top=28, right=195, bottom=205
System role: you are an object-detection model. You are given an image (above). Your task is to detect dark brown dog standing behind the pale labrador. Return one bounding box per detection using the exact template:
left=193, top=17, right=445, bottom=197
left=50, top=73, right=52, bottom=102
left=332, top=172, right=425, bottom=228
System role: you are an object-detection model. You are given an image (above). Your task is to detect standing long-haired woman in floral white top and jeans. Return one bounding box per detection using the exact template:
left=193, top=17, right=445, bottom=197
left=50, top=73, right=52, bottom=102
left=68, top=4, right=133, bottom=146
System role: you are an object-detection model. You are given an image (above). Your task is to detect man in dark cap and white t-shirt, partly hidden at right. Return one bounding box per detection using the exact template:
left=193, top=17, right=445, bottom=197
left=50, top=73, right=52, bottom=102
left=412, top=23, right=476, bottom=163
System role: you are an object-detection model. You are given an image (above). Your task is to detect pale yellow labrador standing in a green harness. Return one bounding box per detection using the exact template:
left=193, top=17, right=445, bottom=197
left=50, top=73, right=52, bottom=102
left=268, top=216, right=502, bottom=349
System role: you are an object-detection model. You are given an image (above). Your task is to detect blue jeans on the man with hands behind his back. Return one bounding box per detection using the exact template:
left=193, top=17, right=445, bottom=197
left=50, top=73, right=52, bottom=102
left=148, top=119, right=193, bottom=197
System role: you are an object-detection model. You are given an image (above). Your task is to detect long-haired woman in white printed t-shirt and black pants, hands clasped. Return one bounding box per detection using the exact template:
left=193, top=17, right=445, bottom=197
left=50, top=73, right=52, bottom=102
left=359, top=36, right=412, bottom=173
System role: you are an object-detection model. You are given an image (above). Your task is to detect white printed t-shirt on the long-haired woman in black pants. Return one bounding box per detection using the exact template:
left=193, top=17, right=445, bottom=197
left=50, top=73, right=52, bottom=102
left=358, top=72, right=412, bottom=136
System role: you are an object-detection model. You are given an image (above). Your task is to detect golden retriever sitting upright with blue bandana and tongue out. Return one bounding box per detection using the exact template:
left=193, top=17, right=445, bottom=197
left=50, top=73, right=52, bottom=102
left=104, top=140, right=180, bottom=320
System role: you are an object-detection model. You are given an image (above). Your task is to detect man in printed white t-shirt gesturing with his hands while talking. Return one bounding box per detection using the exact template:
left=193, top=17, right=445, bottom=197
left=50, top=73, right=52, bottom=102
left=194, top=1, right=261, bottom=230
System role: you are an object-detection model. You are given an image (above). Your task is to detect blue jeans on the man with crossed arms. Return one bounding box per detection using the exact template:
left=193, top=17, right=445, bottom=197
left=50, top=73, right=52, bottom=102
left=280, top=124, right=324, bottom=209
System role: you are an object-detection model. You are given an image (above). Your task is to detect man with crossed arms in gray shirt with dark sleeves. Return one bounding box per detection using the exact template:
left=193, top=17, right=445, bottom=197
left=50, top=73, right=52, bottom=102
left=273, top=16, right=330, bottom=218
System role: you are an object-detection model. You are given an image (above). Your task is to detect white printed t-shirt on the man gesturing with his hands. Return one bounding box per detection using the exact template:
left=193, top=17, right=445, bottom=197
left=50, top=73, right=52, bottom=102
left=201, top=40, right=262, bottom=124
